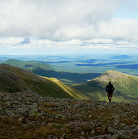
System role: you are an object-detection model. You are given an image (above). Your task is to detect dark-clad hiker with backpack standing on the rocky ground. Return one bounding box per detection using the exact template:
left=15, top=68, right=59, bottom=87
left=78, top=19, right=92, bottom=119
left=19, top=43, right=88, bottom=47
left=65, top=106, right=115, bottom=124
left=106, top=82, right=114, bottom=102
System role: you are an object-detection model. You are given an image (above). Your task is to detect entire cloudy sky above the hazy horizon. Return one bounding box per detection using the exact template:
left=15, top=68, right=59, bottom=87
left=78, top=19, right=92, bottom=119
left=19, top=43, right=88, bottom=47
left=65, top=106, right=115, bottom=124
left=0, top=0, right=138, bottom=55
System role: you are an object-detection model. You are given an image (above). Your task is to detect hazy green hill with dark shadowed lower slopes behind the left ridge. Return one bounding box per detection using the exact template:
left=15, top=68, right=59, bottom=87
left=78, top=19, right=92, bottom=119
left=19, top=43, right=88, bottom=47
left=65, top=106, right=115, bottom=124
left=3, top=59, right=101, bottom=85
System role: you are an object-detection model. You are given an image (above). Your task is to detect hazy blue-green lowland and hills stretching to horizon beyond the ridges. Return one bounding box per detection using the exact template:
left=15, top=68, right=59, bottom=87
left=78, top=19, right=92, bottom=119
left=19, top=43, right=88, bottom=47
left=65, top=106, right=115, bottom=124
left=0, top=54, right=138, bottom=85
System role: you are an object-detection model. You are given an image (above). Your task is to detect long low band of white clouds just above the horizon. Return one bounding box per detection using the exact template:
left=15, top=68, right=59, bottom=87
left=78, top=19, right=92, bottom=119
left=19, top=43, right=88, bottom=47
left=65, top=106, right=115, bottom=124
left=0, top=37, right=138, bottom=52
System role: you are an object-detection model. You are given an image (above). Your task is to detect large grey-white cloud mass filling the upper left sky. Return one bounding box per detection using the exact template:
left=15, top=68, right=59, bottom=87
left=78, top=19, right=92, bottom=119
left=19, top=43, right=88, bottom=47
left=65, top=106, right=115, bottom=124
left=0, top=0, right=118, bottom=40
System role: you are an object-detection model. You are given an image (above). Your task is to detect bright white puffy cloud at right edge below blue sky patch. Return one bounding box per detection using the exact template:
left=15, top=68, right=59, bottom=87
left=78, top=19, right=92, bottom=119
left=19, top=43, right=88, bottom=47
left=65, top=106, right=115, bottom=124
left=99, top=19, right=138, bottom=39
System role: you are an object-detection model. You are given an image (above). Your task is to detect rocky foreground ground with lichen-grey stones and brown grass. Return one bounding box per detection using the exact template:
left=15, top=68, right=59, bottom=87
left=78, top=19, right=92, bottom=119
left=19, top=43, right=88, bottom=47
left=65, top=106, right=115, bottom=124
left=0, top=92, right=138, bottom=139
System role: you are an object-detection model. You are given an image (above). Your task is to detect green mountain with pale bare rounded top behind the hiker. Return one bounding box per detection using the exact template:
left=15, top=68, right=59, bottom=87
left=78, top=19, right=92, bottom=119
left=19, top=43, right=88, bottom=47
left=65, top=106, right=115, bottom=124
left=72, top=70, right=138, bottom=103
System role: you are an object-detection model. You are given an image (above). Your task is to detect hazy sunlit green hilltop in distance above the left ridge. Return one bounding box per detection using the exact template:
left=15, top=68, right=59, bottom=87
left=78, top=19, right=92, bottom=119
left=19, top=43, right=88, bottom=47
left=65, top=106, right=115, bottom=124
left=4, top=59, right=52, bottom=70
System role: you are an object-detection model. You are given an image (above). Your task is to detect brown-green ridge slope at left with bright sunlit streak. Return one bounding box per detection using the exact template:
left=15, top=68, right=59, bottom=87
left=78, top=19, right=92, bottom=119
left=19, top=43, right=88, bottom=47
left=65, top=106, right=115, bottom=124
left=0, top=64, right=87, bottom=99
